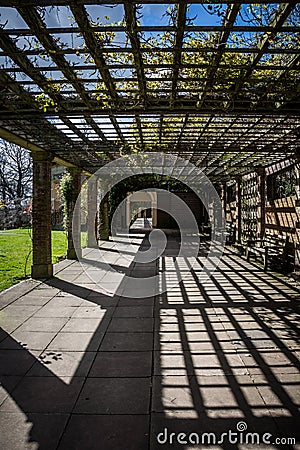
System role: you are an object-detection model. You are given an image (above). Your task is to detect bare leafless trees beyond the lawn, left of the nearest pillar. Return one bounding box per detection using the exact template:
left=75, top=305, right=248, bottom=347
left=0, top=140, right=32, bottom=228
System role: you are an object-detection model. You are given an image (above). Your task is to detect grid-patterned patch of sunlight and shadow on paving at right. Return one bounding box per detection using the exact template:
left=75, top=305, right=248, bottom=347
left=154, top=239, right=300, bottom=442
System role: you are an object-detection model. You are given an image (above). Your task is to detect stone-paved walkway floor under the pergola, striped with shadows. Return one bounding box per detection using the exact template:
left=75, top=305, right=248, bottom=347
left=0, top=235, right=300, bottom=450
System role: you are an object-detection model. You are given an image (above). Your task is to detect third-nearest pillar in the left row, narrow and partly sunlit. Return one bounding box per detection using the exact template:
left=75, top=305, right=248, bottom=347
left=87, top=176, right=98, bottom=248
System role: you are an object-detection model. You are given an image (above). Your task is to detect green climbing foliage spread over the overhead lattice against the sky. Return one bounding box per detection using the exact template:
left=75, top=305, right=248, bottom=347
left=7, top=0, right=300, bottom=155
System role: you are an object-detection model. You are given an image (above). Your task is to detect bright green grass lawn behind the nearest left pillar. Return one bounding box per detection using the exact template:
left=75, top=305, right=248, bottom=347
left=0, top=228, right=67, bottom=291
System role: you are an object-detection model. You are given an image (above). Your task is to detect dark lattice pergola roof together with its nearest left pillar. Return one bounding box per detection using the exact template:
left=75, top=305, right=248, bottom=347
left=0, top=0, right=300, bottom=276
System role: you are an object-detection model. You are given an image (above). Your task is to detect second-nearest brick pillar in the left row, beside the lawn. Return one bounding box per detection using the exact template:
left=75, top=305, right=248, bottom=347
left=67, top=167, right=81, bottom=259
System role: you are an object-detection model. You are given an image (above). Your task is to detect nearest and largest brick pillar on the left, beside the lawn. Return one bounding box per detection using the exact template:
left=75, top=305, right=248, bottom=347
left=31, top=152, right=53, bottom=279
